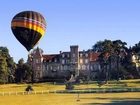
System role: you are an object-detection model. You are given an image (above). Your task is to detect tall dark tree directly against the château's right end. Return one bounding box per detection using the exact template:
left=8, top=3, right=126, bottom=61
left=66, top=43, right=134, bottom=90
left=92, top=39, right=113, bottom=81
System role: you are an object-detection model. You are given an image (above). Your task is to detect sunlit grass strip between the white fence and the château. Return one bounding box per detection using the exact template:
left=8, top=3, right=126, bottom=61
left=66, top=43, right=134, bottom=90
left=0, top=79, right=140, bottom=92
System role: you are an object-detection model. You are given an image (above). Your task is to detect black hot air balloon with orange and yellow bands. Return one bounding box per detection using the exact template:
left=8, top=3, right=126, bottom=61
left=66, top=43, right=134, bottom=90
left=11, top=11, right=46, bottom=51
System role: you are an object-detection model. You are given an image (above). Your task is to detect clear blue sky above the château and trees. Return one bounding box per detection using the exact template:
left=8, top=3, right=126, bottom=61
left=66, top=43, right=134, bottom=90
left=0, top=0, right=140, bottom=62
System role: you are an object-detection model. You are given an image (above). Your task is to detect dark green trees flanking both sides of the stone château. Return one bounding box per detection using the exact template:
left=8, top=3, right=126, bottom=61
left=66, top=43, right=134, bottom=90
left=0, top=39, right=140, bottom=83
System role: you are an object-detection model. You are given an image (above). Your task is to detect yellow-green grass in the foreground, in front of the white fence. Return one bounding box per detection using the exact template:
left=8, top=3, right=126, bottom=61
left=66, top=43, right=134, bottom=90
left=0, top=93, right=140, bottom=105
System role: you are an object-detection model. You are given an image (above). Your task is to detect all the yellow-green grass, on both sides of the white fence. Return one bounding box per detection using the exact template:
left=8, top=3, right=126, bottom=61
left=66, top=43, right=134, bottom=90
left=0, top=80, right=140, bottom=105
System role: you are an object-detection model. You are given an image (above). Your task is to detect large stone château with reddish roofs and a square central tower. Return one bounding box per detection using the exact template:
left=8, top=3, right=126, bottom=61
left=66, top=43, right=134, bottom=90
left=28, top=45, right=100, bottom=81
